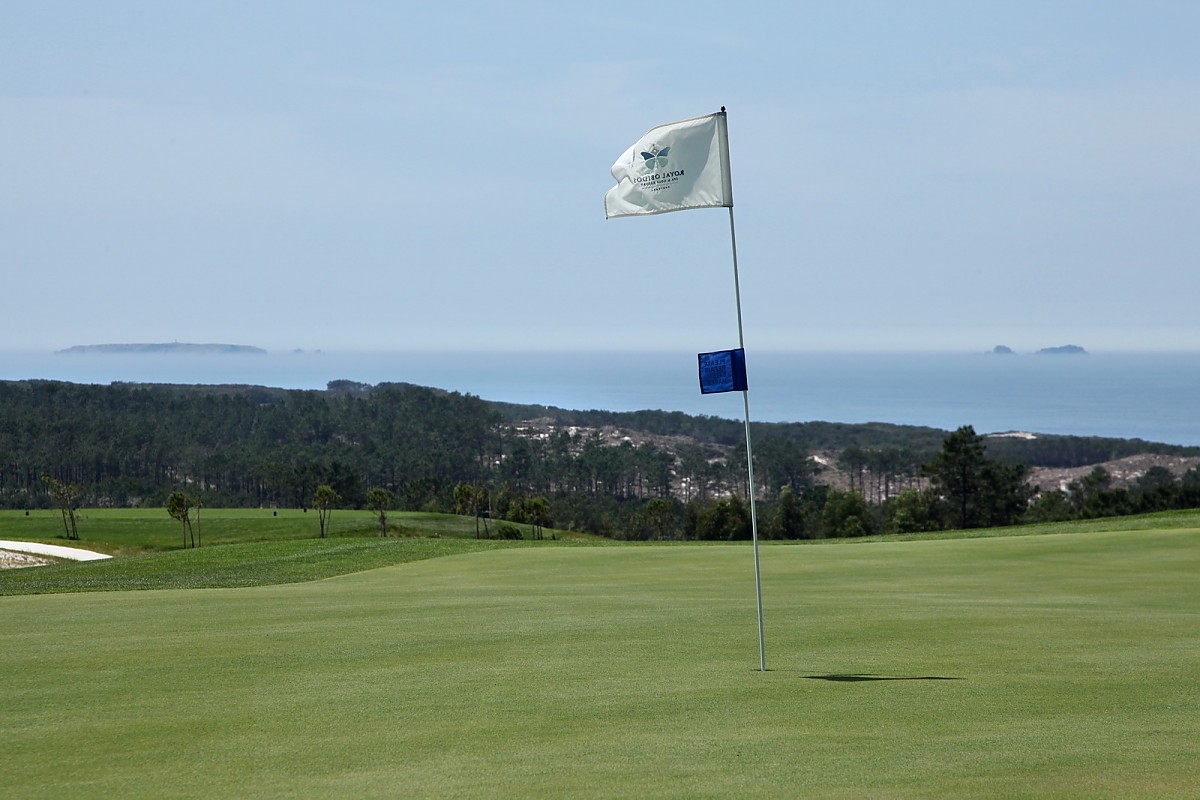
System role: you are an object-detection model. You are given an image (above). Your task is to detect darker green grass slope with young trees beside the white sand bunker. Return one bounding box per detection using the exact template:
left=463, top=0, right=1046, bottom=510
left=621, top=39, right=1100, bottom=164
left=0, top=509, right=595, bottom=595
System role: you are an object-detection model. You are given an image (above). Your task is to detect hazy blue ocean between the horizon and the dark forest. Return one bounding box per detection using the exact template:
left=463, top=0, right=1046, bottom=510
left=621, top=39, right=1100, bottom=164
left=0, top=351, right=1200, bottom=446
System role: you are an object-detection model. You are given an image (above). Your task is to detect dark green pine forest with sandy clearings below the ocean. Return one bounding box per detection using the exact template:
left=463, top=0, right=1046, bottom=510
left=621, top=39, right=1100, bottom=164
left=0, top=380, right=1200, bottom=540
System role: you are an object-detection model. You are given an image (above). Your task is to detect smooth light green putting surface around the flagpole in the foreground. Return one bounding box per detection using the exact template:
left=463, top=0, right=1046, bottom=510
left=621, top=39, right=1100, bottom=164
left=0, top=529, right=1200, bottom=799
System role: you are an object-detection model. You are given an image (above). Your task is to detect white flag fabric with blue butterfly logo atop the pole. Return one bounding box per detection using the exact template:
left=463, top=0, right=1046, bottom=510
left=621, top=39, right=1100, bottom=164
left=604, top=110, right=733, bottom=219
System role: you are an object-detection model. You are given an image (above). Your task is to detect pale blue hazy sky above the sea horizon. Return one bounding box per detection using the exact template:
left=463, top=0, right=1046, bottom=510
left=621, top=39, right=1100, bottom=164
left=0, top=0, right=1200, bottom=351
